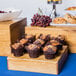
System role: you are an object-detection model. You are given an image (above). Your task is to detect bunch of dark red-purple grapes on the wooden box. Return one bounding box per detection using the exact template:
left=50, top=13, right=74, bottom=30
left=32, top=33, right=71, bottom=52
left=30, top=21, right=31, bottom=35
left=31, top=14, right=52, bottom=27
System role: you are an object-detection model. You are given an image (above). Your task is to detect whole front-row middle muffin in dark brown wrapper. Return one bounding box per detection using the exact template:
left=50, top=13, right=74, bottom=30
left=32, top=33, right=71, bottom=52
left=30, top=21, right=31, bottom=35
left=25, top=44, right=40, bottom=58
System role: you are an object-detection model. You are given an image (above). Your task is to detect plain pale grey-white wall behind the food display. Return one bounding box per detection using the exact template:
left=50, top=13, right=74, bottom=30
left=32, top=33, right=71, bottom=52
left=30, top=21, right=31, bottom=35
left=0, top=0, right=76, bottom=25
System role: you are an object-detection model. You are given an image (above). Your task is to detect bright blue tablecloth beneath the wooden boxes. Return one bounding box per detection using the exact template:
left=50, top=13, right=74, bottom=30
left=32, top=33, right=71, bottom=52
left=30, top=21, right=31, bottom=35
left=0, top=54, right=76, bottom=76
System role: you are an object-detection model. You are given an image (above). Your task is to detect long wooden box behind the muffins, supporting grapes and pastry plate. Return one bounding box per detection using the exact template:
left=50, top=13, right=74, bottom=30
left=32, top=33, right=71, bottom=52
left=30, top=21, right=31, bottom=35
left=25, top=26, right=76, bottom=53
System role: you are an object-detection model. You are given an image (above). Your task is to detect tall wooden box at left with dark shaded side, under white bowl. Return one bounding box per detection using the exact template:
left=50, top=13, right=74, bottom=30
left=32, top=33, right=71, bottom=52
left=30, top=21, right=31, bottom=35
left=0, top=18, right=26, bottom=56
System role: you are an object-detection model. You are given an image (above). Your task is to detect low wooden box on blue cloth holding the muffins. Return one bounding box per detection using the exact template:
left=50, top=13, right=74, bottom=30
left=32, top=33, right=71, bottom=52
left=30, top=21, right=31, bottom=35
left=7, top=46, right=68, bottom=74
